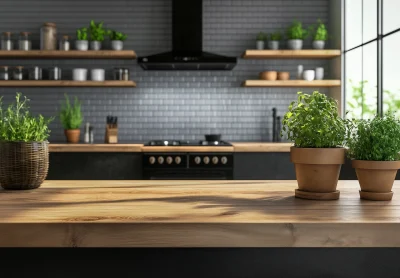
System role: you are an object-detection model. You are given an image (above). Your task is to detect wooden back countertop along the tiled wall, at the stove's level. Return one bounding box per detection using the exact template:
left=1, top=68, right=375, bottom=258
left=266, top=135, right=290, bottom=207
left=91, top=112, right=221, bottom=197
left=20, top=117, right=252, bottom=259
left=49, top=142, right=292, bottom=152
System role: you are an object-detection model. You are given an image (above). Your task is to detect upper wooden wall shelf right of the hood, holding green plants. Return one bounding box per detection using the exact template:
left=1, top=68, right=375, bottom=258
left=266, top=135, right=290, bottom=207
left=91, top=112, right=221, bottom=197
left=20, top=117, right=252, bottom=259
left=242, top=49, right=340, bottom=59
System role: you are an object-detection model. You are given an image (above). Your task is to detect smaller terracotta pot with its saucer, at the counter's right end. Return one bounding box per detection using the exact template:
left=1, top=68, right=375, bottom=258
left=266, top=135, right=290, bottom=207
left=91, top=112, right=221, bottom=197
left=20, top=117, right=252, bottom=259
left=352, top=160, right=400, bottom=201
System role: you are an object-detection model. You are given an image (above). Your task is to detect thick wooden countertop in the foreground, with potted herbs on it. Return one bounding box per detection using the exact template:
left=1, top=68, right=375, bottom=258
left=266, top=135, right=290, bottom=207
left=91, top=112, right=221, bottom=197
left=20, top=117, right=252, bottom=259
left=0, top=181, right=400, bottom=247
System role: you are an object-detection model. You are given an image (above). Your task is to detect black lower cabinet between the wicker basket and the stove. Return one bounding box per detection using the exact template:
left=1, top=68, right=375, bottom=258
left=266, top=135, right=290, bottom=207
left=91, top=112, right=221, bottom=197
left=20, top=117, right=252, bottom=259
left=47, top=152, right=142, bottom=180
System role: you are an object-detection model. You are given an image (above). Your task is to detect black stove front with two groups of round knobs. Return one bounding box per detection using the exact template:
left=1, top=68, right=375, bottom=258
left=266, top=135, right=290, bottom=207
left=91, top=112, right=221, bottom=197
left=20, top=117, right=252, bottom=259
left=143, top=152, right=233, bottom=180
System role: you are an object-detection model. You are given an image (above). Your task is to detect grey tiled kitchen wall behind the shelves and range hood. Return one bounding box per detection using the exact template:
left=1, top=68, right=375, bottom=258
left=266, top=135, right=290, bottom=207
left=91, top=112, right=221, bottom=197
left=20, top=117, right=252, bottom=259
left=0, top=0, right=329, bottom=142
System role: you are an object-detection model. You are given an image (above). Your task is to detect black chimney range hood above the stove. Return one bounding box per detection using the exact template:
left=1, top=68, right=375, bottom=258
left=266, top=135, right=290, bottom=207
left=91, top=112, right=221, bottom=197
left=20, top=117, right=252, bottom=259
left=138, top=0, right=237, bottom=70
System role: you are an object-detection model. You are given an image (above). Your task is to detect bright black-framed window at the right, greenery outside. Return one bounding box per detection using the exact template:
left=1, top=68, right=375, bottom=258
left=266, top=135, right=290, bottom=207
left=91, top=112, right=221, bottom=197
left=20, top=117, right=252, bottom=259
left=344, top=0, right=400, bottom=119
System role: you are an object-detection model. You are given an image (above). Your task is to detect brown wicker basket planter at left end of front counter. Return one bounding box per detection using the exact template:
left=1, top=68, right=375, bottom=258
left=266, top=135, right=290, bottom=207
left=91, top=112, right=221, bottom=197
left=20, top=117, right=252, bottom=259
left=0, top=141, right=49, bottom=189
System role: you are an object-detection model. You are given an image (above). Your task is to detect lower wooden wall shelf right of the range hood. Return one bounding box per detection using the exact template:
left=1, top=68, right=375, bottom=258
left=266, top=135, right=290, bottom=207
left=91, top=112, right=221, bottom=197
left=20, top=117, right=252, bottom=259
left=242, top=80, right=341, bottom=87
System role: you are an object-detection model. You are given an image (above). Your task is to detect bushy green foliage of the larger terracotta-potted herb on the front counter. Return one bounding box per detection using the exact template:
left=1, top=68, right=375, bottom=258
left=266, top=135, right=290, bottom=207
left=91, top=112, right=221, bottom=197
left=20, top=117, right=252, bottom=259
left=281, top=91, right=346, bottom=148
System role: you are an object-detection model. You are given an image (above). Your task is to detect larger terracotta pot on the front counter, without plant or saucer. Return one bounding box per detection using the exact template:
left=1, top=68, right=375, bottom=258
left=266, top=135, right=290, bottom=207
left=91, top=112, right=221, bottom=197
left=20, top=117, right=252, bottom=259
left=290, top=147, right=345, bottom=193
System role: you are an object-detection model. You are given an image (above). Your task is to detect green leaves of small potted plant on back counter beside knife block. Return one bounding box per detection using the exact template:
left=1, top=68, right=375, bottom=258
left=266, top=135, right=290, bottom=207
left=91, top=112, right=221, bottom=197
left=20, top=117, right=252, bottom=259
left=60, top=94, right=83, bottom=129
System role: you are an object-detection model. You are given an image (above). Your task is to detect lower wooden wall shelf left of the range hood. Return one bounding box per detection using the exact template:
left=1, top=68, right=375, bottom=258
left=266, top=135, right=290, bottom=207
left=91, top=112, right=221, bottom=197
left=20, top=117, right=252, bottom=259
left=0, top=80, right=136, bottom=87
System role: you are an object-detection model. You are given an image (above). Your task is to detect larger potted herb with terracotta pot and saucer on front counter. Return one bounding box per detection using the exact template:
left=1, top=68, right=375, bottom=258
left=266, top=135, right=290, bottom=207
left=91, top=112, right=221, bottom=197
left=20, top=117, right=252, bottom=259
left=281, top=91, right=346, bottom=200
